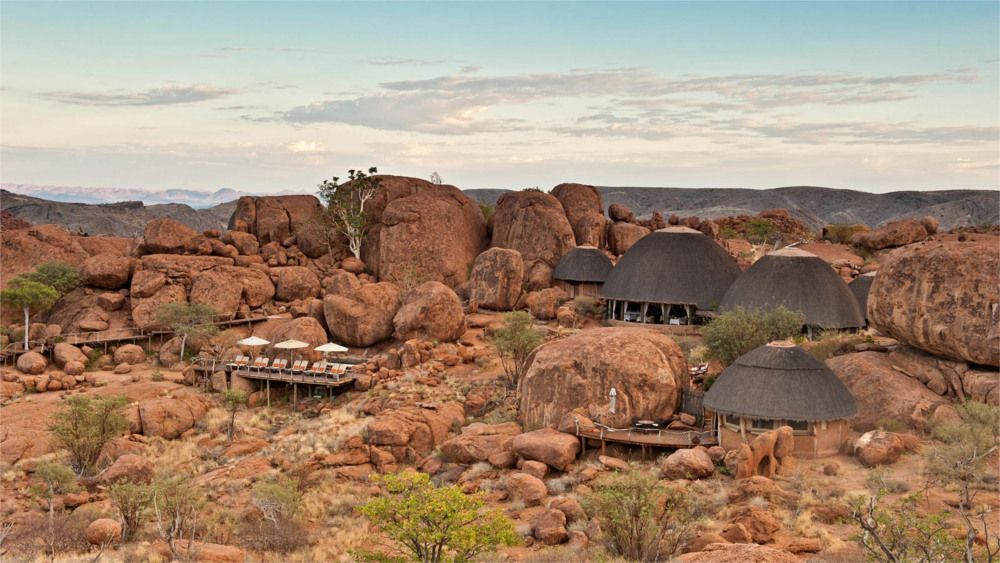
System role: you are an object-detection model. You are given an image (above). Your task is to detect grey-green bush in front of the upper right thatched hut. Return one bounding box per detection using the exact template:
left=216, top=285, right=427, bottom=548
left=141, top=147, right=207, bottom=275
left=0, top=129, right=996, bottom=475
left=701, top=307, right=805, bottom=366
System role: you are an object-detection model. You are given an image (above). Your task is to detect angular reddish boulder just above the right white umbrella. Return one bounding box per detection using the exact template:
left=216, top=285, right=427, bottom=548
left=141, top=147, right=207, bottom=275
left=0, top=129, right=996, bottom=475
left=323, top=282, right=403, bottom=347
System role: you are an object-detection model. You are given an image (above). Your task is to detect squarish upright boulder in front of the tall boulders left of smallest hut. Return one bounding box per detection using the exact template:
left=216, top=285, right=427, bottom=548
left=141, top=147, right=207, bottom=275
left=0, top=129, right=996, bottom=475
left=466, top=248, right=524, bottom=311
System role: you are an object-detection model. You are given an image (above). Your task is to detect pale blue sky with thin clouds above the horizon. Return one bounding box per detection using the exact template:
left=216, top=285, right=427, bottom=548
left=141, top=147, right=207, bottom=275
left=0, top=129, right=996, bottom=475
left=0, top=0, right=1000, bottom=192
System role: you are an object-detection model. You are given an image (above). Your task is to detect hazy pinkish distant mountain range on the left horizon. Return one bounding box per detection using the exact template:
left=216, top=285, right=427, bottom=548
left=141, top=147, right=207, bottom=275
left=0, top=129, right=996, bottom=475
left=0, top=184, right=295, bottom=209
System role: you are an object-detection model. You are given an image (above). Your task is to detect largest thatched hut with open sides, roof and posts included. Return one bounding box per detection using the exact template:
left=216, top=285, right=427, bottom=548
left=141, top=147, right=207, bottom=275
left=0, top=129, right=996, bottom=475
left=601, top=227, right=740, bottom=324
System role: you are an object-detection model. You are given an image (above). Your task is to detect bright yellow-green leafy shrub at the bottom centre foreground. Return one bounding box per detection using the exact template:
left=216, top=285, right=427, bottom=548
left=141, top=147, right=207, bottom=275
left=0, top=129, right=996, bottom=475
left=352, top=473, right=518, bottom=563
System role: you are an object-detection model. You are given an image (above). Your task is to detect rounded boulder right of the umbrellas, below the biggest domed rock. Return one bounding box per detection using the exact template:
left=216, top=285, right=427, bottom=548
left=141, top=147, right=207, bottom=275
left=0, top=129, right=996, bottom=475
left=392, top=281, right=466, bottom=342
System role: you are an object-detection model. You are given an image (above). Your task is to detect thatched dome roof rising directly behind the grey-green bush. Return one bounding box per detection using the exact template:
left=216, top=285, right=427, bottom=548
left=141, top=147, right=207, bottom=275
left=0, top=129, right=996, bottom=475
left=719, top=248, right=865, bottom=328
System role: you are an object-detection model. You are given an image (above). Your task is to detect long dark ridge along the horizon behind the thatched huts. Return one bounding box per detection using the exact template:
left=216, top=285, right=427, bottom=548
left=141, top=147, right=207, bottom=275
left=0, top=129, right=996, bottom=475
left=465, top=186, right=1000, bottom=230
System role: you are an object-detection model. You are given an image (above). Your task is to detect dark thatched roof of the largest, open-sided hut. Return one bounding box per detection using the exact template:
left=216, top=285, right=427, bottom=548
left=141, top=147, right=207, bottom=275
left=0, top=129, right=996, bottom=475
left=601, top=227, right=740, bottom=309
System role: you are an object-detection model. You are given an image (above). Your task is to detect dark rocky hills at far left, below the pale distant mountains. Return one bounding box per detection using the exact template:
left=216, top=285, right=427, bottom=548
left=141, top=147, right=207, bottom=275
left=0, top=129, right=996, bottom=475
left=0, top=190, right=236, bottom=237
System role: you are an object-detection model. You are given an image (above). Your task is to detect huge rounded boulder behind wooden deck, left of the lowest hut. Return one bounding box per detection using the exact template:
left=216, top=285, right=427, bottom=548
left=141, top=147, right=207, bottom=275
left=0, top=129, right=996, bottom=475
left=517, top=327, right=688, bottom=428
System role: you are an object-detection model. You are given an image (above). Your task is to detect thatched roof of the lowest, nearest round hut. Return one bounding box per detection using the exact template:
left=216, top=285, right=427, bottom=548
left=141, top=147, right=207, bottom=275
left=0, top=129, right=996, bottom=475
left=703, top=342, right=858, bottom=422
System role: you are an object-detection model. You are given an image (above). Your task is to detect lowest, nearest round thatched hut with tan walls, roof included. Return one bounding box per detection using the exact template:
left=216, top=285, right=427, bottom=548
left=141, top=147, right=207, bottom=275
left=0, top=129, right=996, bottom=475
left=703, top=342, right=858, bottom=458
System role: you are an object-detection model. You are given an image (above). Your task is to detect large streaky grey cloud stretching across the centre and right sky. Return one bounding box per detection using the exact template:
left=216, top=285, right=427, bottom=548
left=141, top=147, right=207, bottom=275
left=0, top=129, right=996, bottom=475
left=281, top=64, right=979, bottom=137
